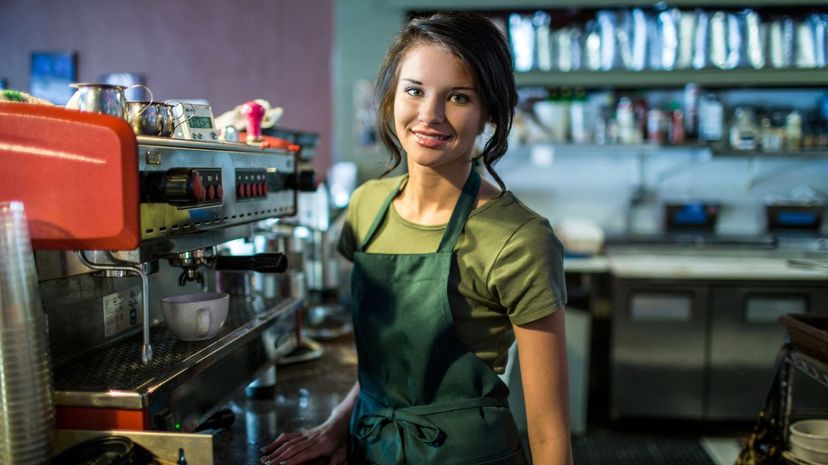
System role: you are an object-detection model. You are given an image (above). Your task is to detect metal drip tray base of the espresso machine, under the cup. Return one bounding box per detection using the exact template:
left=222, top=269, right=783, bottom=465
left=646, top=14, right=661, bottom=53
left=54, top=297, right=302, bottom=431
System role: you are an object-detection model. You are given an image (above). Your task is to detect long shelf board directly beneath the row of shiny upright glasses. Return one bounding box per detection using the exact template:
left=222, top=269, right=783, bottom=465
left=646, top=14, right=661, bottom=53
left=515, top=68, right=828, bottom=89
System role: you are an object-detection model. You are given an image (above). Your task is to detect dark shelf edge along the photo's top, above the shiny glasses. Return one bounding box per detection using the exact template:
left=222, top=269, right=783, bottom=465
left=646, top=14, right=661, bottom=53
left=392, top=0, right=826, bottom=11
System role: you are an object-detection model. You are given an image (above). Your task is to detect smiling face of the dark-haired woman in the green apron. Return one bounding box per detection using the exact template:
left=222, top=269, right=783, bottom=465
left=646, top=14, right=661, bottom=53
left=394, top=45, right=483, bottom=169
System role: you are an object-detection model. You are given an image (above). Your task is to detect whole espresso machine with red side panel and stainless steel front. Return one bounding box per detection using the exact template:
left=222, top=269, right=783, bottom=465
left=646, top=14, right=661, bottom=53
left=0, top=103, right=307, bottom=432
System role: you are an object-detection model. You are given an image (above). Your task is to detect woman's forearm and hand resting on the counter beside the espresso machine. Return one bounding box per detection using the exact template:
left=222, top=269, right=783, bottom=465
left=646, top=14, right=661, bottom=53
left=261, top=382, right=359, bottom=465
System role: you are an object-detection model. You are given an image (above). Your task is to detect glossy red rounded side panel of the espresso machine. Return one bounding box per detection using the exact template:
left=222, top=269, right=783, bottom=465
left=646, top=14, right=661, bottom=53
left=0, top=102, right=141, bottom=250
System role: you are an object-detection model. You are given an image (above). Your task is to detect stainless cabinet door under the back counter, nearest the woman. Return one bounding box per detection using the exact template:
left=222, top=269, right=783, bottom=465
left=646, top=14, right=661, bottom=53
left=610, top=280, right=707, bottom=419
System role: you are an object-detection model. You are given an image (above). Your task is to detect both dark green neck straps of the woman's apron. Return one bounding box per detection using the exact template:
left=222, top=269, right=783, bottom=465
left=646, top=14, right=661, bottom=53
left=357, top=169, right=480, bottom=252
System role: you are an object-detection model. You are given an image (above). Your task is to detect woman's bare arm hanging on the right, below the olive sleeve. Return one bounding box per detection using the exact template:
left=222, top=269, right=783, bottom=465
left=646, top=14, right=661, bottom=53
left=514, top=309, right=572, bottom=465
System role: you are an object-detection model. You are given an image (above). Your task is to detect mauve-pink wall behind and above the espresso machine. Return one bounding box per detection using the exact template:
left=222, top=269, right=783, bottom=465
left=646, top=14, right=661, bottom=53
left=0, top=0, right=333, bottom=172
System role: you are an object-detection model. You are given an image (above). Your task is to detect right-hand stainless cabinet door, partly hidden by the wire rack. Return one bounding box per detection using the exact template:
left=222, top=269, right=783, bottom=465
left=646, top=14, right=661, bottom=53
left=706, top=283, right=828, bottom=420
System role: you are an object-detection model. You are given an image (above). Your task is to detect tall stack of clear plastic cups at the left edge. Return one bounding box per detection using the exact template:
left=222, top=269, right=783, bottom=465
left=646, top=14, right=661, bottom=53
left=0, top=202, right=54, bottom=465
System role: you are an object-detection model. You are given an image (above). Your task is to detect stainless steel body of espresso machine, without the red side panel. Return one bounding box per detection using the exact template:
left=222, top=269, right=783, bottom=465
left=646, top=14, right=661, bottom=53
left=36, top=136, right=302, bottom=431
